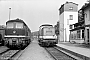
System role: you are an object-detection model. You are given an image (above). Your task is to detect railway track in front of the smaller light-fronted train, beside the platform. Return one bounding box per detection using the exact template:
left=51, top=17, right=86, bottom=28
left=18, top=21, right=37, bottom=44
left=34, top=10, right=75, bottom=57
left=45, top=47, right=83, bottom=60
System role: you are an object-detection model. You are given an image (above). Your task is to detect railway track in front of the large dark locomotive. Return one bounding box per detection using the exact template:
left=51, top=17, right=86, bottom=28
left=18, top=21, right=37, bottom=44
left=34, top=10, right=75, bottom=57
left=0, top=50, right=20, bottom=60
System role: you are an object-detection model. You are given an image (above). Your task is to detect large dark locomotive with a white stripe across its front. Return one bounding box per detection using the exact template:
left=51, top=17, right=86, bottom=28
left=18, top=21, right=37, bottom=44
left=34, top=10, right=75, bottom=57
left=4, top=18, right=31, bottom=49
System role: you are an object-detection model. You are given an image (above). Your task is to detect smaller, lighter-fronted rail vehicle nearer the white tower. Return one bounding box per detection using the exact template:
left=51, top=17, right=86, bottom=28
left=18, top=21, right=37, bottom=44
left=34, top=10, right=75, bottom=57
left=38, top=24, right=57, bottom=46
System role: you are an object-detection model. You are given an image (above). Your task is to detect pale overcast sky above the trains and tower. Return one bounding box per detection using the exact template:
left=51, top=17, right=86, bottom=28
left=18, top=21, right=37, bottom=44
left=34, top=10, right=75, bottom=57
left=0, top=0, right=87, bottom=32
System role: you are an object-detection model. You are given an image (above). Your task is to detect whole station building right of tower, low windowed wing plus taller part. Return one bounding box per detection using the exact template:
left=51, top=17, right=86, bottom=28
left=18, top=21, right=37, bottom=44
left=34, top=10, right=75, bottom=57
left=70, top=2, right=90, bottom=44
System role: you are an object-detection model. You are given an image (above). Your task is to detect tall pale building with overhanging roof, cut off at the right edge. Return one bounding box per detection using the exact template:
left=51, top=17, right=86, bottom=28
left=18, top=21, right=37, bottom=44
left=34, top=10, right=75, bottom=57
left=81, top=2, right=90, bottom=44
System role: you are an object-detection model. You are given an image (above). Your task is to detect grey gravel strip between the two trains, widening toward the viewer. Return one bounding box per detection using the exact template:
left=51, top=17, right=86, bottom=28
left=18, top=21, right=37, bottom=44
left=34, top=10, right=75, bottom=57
left=18, top=40, right=54, bottom=60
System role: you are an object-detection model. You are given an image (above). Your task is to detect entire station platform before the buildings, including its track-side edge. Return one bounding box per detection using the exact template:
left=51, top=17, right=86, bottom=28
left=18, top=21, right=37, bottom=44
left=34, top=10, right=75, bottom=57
left=57, top=42, right=90, bottom=60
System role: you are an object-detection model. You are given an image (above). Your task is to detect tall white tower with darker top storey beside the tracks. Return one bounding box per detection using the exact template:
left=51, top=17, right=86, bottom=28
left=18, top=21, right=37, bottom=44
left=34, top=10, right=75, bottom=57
left=58, top=2, right=78, bottom=42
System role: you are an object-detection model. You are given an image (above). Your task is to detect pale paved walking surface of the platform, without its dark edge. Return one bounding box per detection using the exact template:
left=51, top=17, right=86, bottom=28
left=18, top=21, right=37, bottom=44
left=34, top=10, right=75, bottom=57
left=57, top=43, right=90, bottom=57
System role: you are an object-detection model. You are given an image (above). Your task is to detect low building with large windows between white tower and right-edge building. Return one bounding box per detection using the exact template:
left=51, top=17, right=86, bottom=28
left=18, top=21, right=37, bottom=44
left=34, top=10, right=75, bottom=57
left=69, top=21, right=85, bottom=43
